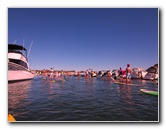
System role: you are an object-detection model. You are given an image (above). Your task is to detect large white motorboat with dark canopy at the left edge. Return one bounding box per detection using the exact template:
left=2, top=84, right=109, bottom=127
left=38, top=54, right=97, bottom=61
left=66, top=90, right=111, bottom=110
left=8, top=44, right=34, bottom=82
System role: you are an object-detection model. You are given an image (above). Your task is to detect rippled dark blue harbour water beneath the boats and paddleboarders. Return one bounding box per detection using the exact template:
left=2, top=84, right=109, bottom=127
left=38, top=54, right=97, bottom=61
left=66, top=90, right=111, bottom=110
left=8, top=76, right=159, bottom=121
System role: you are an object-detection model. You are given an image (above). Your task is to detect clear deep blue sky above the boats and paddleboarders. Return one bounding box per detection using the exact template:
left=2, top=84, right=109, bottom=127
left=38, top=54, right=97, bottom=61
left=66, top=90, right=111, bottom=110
left=8, top=8, right=158, bottom=70
